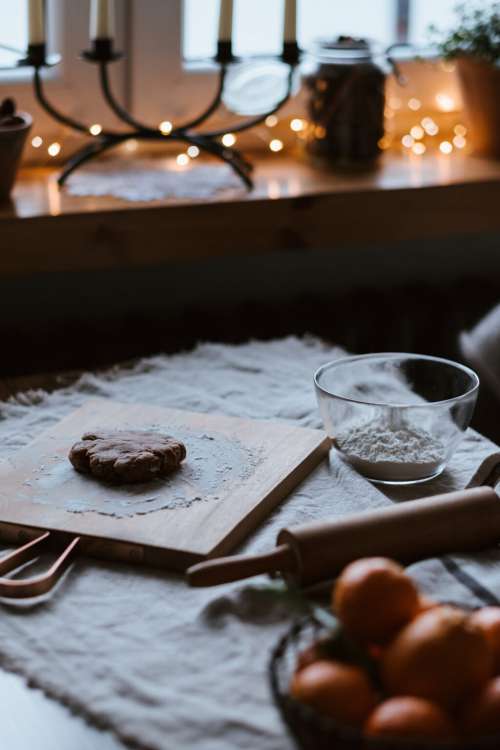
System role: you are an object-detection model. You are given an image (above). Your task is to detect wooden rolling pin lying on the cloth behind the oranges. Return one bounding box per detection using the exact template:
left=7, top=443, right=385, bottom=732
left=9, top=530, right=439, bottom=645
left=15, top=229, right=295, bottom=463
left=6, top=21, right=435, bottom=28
left=187, top=487, right=500, bottom=587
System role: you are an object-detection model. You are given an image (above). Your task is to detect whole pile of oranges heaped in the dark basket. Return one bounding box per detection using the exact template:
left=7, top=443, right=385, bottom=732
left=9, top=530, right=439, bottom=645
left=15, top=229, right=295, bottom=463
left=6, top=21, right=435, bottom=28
left=290, top=558, right=500, bottom=747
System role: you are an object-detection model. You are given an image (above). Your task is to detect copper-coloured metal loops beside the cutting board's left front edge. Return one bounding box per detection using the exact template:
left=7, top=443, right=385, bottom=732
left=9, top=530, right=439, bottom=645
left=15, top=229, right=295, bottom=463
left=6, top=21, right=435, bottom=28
left=0, top=531, right=80, bottom=599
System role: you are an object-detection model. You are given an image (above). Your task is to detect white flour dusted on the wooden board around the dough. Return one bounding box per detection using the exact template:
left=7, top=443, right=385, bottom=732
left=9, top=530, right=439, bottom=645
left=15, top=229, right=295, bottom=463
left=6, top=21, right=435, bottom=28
left=20, top=425, right=263, bottom=518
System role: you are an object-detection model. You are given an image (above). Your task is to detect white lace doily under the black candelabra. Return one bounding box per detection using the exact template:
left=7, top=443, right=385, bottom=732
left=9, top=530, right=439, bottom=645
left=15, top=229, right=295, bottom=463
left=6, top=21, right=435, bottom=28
left=67, top=158, right=245, bottom=202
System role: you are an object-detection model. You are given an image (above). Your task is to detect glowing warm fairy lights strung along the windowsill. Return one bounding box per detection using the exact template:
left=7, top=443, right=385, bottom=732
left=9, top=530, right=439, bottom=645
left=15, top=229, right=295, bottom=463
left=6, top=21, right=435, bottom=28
left=31, top=92, right=468, bottom=167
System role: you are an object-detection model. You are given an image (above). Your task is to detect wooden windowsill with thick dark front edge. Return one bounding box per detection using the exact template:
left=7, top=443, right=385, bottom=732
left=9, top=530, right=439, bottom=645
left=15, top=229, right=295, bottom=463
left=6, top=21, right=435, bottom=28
left=0, top=154, right=500, bottom=276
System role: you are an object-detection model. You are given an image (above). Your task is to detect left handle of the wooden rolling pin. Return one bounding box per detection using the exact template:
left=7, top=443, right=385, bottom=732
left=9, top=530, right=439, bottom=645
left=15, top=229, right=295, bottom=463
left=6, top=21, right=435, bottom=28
left=187, top=544, right=297, bottom=588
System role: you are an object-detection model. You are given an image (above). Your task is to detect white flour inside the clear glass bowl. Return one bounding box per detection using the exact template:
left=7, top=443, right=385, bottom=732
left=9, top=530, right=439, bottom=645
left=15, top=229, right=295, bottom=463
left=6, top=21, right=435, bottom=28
left=334, top=420, right=445, bottom=482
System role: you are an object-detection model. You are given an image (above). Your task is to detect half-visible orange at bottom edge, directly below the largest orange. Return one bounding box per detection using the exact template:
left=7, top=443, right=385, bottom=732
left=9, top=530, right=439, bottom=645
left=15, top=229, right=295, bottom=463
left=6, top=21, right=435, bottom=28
left=365, top=696, right=456, bottom=740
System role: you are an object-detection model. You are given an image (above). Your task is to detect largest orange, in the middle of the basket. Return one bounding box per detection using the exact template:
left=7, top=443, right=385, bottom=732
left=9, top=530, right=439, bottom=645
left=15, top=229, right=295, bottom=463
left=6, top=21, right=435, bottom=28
left=382, top=607, right=493, bottom=708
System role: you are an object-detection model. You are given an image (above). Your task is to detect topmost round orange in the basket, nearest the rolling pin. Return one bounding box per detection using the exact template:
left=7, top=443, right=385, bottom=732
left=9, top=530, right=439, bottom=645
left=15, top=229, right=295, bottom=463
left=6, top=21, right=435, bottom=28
left=333, top=557, right=420, bottom=643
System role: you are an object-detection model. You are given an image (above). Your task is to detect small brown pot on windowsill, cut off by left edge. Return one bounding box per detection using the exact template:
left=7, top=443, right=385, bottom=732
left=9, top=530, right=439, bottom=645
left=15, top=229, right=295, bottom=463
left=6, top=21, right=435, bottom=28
left=0, top=99, right=33, bottom=201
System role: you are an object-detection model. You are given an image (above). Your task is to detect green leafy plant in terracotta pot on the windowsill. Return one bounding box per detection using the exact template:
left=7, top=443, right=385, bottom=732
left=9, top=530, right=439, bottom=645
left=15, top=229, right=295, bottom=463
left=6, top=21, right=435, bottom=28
left=434, top=2, right=500, bottom=157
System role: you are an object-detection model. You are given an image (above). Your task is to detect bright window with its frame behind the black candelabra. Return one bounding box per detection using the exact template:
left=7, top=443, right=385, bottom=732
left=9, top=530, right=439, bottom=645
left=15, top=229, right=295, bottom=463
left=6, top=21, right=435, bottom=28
left=0, top=0, right=491, bottom=156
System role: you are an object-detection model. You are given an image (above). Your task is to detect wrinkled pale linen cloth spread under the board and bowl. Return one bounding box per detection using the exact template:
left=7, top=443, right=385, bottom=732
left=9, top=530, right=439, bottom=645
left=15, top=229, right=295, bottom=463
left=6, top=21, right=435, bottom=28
left=0, top=338, right=500, bottom=750
